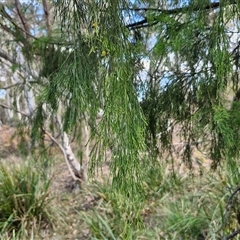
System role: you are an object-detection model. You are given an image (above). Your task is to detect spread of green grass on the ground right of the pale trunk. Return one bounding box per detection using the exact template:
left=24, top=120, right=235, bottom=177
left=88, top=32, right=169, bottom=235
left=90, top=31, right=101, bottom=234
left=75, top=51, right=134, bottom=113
left=78, top=158, right=240, bottom=240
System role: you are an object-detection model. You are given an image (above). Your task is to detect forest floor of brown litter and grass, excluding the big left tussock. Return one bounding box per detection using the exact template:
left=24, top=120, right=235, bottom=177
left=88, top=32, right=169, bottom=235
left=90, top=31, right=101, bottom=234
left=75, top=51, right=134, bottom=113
left=0, top=125, right=240, bottom=240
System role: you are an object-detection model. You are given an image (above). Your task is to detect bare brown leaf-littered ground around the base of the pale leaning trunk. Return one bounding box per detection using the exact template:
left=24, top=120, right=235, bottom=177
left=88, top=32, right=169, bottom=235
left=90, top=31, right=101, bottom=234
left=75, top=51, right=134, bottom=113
left=0, top=125, right=112, bottom=240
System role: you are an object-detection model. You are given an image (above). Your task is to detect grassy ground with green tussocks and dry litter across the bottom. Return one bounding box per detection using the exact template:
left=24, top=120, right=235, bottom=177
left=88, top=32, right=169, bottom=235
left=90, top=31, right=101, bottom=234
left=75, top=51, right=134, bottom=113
left=0, top=153, right=240, bottom=240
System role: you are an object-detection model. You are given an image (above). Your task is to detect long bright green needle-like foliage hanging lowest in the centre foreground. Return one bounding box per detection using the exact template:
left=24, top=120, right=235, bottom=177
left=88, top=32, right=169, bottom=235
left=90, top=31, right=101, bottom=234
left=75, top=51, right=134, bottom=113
left=36, top=1, right=146, bottom=197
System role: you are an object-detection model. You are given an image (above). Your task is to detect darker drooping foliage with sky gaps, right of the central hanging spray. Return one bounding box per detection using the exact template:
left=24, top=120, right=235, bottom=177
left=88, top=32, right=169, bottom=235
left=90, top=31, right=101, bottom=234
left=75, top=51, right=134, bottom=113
left=127, top=1, right=239, bottom=169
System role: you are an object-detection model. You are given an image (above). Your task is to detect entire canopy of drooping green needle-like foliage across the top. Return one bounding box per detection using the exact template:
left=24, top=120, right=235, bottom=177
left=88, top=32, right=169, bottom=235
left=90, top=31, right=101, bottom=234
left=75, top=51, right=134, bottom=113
left=0, top=0, right=240, bottom=195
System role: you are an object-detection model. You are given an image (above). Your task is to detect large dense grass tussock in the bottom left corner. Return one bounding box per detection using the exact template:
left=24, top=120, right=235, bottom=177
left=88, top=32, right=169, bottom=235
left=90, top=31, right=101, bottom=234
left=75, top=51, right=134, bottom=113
left=0, top=159, right=54, bottom=239
